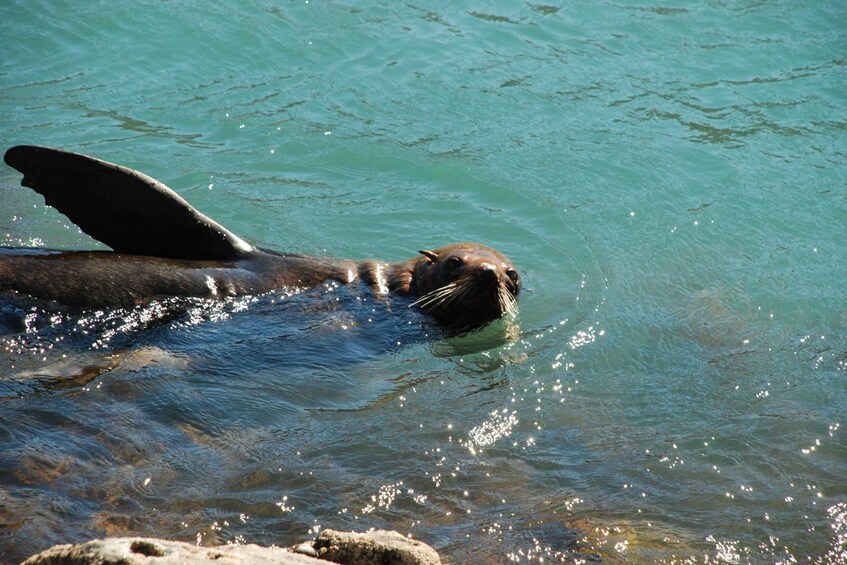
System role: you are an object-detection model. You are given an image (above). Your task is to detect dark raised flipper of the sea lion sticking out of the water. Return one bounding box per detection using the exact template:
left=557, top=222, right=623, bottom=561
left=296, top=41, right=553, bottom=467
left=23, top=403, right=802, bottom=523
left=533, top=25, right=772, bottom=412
left=4, top=145, right=255, bottom=260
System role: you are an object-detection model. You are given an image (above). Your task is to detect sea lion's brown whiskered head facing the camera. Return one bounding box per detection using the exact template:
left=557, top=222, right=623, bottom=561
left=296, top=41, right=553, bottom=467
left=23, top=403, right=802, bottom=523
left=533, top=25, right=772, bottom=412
left=410, top=243, right=521, bottom=328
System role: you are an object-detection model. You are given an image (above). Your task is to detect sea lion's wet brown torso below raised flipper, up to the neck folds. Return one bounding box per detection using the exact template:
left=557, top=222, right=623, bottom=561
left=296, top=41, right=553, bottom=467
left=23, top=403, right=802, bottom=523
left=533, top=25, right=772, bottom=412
left=0, top=250, right=357, bottom=308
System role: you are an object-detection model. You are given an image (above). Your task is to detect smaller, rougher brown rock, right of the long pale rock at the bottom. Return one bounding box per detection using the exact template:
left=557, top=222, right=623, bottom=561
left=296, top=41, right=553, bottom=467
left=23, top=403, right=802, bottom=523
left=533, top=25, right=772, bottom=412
left=313, top=530, right=441, bottom=565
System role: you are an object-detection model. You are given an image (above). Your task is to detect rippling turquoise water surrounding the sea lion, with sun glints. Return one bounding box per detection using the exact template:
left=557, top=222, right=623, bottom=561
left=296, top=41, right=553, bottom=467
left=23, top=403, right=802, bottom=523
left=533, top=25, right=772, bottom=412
left=0, top=0, right=847, bottom=563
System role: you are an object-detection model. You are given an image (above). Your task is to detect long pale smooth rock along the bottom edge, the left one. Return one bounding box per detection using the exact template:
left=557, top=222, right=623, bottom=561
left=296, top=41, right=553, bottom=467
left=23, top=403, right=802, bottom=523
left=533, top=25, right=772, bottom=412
left=24, top=538, right=326, bottom=565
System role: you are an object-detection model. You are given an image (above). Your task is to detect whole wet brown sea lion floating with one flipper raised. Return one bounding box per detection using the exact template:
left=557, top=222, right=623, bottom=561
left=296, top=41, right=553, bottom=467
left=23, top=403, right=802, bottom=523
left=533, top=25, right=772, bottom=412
left=0, top=146, right=521, bottom=328
